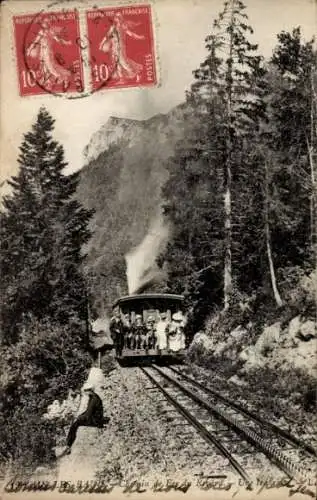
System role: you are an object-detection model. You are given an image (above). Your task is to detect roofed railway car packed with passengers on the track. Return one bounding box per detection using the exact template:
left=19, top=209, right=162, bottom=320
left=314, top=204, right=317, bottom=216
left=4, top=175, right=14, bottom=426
left=110, top=293, right=186, bottom=362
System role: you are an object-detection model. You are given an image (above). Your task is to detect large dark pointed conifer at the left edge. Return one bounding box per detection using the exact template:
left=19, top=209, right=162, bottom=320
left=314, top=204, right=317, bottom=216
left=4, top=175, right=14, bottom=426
left=1, top=108, right=92, bottom=342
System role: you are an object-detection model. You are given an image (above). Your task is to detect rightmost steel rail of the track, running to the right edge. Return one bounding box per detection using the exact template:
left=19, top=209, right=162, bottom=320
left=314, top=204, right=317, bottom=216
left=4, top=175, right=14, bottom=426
left=168, top=366, right=317, bottom=457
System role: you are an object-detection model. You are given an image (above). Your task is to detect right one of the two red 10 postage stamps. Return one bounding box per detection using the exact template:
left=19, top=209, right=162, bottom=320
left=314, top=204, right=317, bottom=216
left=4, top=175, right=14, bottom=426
left=86, top=5, right=157, bottom=91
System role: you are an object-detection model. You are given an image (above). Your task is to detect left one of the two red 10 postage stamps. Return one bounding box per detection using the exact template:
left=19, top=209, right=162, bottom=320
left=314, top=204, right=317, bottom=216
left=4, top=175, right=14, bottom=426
left=13, top=11, right=84, bottom=96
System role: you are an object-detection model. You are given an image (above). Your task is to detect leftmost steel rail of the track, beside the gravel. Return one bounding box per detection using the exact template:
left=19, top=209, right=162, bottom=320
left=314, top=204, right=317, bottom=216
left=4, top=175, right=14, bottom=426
left=140, top=367, right=252, bottom=489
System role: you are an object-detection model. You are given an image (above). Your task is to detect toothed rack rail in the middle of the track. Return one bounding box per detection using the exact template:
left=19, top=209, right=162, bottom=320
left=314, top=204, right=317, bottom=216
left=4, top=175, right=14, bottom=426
left=152, top=366, right=306, bottom=479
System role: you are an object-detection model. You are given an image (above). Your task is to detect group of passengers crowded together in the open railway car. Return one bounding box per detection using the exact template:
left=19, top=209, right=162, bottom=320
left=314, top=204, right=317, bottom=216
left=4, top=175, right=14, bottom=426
left=110, top=311, right=185, bottom=356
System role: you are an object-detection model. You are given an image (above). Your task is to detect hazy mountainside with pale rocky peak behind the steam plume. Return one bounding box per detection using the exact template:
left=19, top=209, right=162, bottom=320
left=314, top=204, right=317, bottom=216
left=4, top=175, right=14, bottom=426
left=78, top=104, right=186, bottom=313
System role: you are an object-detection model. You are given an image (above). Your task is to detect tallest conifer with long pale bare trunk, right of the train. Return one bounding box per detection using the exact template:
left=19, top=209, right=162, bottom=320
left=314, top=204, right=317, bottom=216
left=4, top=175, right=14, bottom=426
left=199, top=0, right=264, bottom=309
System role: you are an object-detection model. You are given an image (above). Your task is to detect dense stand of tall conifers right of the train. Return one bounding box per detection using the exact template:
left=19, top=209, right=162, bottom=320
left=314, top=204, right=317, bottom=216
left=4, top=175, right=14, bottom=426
left=159, top=0, right=317, bottom=327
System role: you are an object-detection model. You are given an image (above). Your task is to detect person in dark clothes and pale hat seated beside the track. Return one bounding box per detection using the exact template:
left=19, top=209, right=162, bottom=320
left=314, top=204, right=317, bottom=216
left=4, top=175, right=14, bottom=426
left=62, top=384, right=109, bottom=455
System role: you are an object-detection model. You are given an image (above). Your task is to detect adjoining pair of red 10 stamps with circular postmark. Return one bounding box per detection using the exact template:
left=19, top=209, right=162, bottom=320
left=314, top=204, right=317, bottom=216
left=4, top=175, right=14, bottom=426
left=13, top=3, right=157, bottom=98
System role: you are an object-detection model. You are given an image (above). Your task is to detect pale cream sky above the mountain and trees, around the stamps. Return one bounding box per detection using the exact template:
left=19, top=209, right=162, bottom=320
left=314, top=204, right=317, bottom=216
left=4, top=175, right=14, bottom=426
left=0, top=0, right=317, bottom=186
